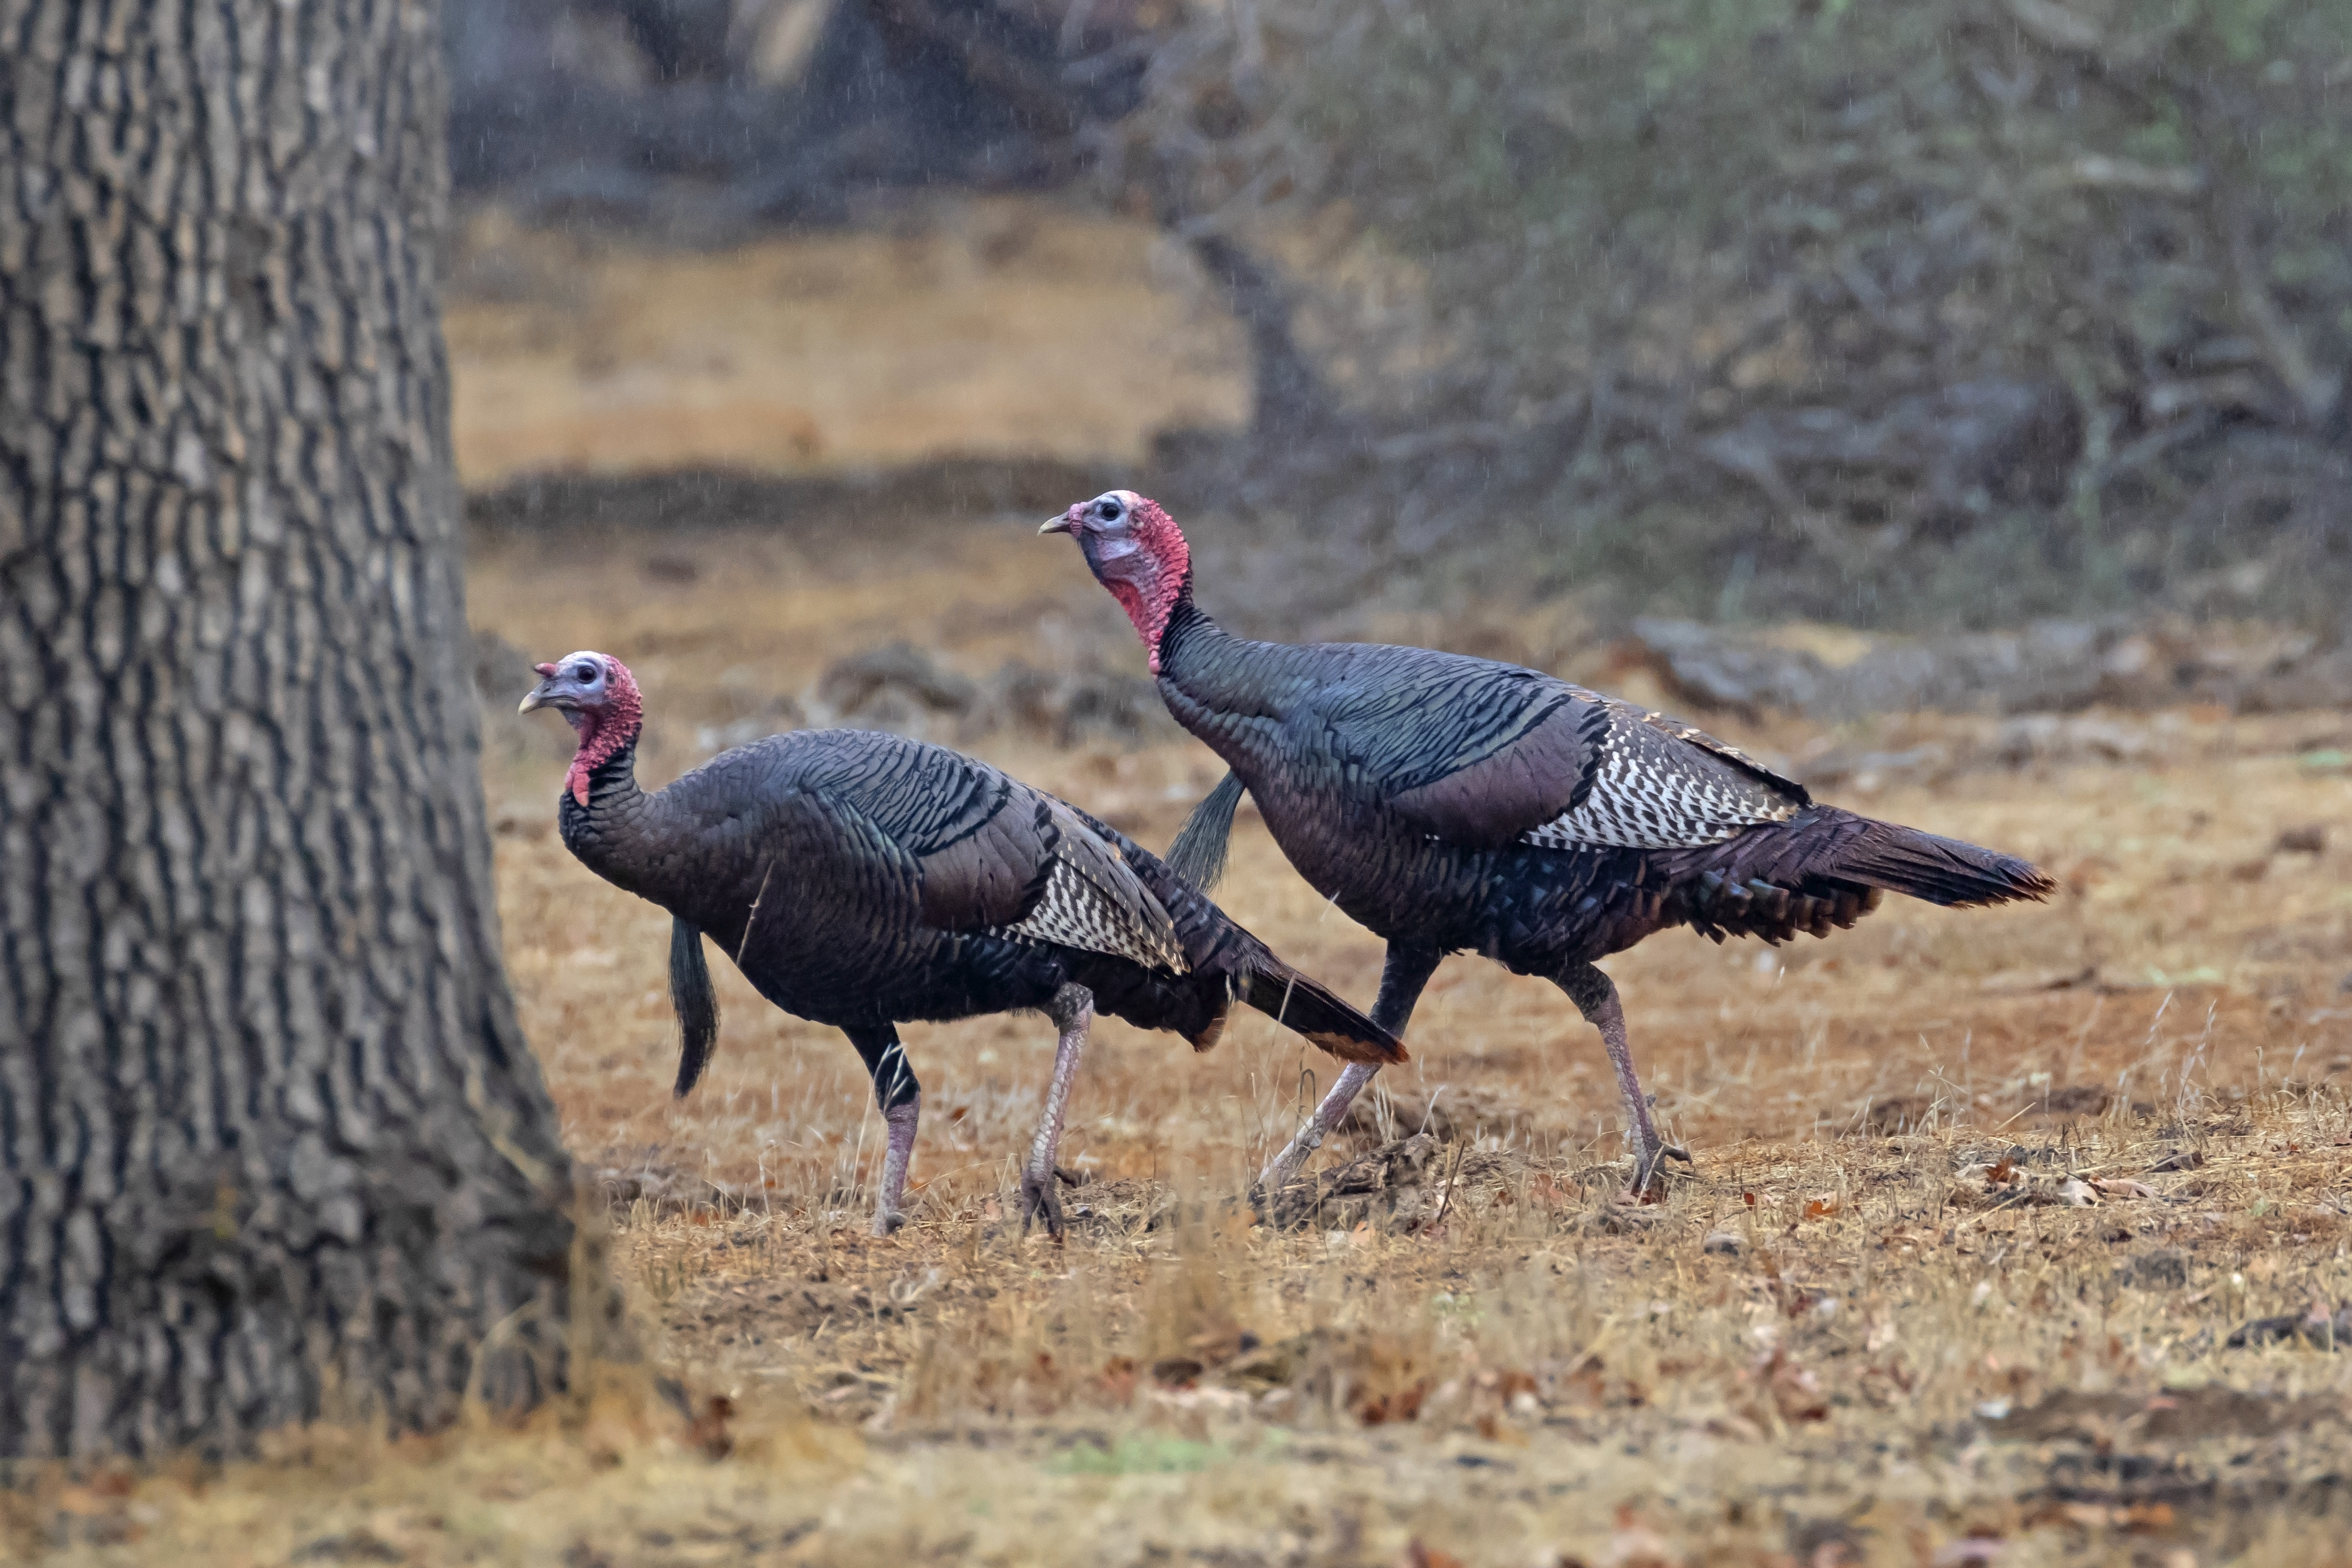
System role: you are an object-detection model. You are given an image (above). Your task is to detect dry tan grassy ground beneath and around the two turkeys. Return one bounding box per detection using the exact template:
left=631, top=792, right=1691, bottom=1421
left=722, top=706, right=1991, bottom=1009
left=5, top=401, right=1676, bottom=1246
left=18, top=212, right=2352, bottom=1568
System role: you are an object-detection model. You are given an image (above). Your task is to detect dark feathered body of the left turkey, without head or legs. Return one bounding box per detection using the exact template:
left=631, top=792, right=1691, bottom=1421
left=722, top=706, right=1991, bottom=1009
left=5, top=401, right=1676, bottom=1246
left=558, top=731, right=1256, bottom=1044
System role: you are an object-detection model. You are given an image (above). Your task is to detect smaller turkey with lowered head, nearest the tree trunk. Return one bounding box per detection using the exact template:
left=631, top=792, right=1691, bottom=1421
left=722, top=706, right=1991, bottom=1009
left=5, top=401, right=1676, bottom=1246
left=522, top=654, right=1404, bottom=1237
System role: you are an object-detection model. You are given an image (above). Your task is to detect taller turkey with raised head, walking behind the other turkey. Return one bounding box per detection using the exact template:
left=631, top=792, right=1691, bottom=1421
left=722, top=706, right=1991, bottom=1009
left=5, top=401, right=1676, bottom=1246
left=1040, top=489, right=2051, bottom=1192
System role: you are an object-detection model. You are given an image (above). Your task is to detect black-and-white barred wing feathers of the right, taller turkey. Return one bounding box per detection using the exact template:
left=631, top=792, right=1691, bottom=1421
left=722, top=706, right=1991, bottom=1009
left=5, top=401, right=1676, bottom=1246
left=1519, top=701, right=1809, bottom=849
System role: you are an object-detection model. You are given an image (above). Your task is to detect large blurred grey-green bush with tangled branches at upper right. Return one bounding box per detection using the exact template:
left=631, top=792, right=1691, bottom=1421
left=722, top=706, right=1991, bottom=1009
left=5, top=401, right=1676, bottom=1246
left=1089, top=0, right=2352, bottom=625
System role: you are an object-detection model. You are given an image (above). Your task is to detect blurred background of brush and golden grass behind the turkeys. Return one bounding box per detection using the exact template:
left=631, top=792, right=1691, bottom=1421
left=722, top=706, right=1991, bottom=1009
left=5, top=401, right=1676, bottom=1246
left=449, top=0, right=2352, bottom=707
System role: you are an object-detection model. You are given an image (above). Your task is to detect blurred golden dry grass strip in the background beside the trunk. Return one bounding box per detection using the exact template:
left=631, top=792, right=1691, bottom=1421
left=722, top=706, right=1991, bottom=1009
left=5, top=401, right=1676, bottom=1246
left=447, top=195, right=1249, bottom=484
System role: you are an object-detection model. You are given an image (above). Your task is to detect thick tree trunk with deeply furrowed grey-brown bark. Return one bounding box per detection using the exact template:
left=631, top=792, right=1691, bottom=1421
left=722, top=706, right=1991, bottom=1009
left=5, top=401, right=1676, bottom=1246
left=0, top=0, right=572, bottom=1455
